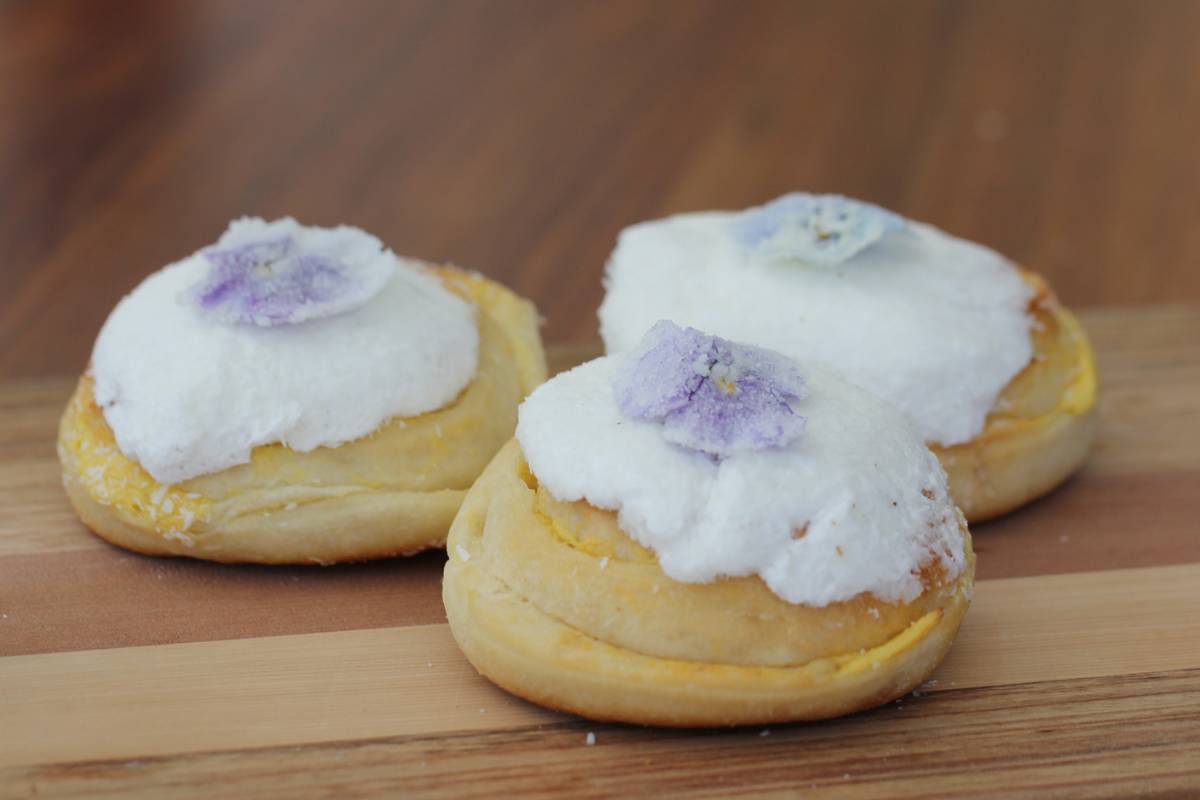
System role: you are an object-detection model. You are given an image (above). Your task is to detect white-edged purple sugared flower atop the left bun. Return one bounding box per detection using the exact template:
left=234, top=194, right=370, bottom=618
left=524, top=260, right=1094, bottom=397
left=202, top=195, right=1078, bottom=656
left=184, top=219, right=392, bottom=327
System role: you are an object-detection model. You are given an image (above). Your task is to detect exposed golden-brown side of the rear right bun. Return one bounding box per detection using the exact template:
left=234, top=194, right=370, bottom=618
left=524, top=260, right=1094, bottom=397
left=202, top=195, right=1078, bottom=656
left=929, top=272, right=1096, bottom=523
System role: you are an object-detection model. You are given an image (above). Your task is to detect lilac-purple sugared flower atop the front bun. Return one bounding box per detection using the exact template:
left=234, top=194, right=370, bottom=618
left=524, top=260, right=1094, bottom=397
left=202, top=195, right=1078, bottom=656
left=612, top=319, right=808, bottom=457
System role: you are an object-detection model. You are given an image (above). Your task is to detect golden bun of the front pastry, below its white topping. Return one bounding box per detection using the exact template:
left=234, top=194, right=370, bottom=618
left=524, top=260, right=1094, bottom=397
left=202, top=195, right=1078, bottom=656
left=443, top=441, right=974, bottom=727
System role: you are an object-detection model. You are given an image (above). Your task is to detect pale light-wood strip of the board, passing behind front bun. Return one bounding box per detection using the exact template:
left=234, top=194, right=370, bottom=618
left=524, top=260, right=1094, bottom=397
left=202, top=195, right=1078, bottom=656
left=0, top=564, right=1200, bottom=765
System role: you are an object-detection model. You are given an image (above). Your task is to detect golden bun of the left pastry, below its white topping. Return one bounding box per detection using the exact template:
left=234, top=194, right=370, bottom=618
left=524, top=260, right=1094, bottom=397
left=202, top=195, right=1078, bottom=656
left=59, top=267, right=546, bottom=564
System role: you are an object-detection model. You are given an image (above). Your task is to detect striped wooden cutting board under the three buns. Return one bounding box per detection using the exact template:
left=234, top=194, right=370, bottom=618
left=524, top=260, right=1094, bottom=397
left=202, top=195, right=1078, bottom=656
left=0, top=307, right=1200, bottom=798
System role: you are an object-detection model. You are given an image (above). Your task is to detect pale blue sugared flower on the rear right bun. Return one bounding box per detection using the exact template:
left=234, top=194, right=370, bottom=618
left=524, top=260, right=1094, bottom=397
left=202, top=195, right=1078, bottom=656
left=732, top=192, right=906, bottom=266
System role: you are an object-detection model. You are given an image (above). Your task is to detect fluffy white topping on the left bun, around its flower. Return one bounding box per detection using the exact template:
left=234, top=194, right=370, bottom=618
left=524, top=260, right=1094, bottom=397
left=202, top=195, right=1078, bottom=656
left=91, top=219, right=479, bottom=485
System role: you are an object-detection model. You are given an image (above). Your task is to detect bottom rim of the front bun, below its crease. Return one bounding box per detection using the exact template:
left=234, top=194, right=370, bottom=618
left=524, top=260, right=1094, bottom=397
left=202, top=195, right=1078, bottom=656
left=443, top=443, right=974, bottom=727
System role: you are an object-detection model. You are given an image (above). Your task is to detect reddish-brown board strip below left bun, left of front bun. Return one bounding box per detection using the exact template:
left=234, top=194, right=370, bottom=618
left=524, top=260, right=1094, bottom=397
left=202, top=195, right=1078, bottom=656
left=0, top=551, right=445, bottom=656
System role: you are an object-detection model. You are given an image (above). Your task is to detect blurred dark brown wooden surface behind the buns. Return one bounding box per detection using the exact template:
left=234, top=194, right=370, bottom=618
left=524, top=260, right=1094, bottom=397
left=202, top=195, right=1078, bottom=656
left=7, top=0, right=1200, bottom=377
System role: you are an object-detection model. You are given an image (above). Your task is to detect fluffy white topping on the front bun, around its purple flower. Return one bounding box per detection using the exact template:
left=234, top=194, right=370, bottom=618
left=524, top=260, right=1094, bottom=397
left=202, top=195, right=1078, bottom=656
left=516, top=356, right=966, bottom=606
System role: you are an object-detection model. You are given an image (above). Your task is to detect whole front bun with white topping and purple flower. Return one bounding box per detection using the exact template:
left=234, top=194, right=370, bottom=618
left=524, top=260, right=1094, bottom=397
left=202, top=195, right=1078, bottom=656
left=443, top=321, right=974, bottom=726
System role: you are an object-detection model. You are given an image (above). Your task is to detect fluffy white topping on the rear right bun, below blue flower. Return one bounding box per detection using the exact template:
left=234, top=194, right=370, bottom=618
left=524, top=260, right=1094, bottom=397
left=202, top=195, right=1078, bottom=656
left=599, top=206, right=1033, bottom=445
